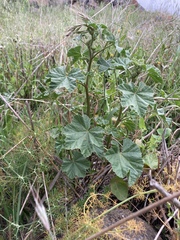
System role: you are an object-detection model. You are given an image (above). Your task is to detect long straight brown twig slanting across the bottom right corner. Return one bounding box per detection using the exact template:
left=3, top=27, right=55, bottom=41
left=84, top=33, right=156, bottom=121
left=86, top=192, right=180, bottom=240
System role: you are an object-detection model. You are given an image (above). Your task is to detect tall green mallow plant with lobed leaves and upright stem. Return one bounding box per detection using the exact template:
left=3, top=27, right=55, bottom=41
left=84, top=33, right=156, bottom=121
left=46, top=17, right=162, bottom=199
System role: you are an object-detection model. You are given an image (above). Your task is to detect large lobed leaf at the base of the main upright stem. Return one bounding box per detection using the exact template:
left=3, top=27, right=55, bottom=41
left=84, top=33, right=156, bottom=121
left=63, top=115, right=104, bottom=157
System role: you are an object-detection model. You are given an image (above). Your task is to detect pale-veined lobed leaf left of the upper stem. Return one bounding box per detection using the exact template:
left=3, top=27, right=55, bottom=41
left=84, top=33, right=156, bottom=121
left=46, top=66, right=85, bottom=93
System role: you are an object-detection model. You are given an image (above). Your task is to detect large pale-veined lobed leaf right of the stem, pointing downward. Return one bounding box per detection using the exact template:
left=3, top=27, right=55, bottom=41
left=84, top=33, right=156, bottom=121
left=119, top=82, right=154, bottom=117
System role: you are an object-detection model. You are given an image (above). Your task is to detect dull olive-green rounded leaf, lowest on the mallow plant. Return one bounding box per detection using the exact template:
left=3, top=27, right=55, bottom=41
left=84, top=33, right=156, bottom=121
left=110, top=176, right=128, bottom=201
